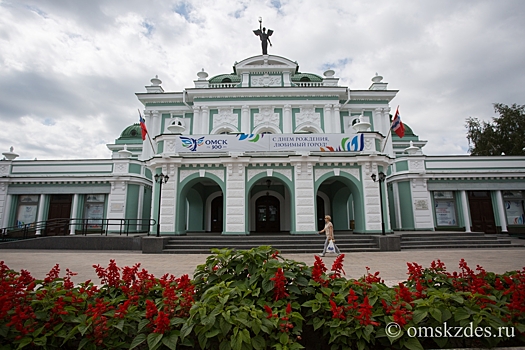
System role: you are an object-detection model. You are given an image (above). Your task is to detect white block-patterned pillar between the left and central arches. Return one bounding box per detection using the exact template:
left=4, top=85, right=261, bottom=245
left=222, top=162, right=245, bottom=235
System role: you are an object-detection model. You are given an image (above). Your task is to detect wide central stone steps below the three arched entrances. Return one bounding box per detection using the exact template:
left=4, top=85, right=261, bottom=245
left=163, top=232, right=379, bottom=254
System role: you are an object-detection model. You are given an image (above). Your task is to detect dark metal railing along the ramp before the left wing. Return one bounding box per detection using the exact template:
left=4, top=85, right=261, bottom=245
left=0, top=219, right=156, bottom=242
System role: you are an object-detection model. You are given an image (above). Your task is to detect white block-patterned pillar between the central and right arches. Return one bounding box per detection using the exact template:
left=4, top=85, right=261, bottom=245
left=291, top=157, right=317, bottom=234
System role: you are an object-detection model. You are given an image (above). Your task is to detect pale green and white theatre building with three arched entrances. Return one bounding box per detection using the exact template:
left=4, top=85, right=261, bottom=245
left=0, top=55, right=525, bottom=235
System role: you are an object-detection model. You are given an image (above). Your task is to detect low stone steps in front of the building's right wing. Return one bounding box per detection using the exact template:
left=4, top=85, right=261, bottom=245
left=400, top=232, right=525, bottom=250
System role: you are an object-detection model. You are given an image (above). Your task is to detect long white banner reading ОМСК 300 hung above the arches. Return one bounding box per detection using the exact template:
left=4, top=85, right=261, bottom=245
left=175, top=134, right=364, bottom=153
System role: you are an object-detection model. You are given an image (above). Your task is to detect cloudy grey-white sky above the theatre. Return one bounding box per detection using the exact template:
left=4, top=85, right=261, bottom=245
left=0, top=0, right=525, bottom=159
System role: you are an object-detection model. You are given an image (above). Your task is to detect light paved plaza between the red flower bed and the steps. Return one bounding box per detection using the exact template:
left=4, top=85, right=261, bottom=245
left=0, top=248, right=525, bottom=285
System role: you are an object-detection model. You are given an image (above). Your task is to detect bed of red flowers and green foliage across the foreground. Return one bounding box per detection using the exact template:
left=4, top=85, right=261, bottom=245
left=0, top=247, right=525, bottom=350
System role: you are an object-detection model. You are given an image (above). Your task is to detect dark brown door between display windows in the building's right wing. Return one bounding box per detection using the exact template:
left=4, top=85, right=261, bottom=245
left=469, top=191, right=496, bottom=233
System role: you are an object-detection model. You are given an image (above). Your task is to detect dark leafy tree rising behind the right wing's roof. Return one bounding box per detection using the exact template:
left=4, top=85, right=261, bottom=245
left=466, top=103, right=525, bottom=156
